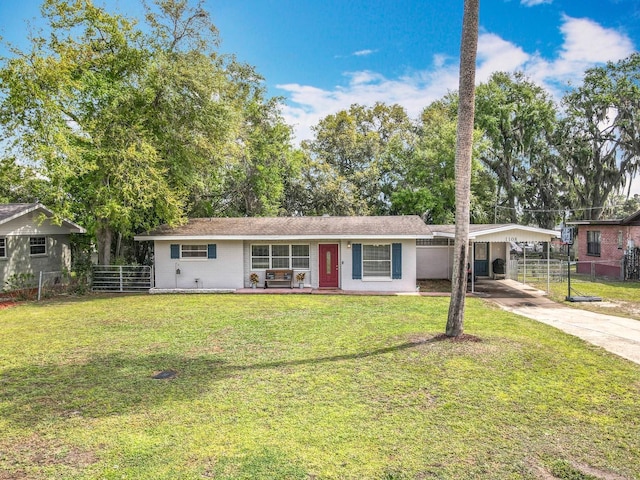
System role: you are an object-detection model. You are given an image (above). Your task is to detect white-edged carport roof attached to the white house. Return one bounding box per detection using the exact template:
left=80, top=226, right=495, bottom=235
left=429, top=223, right=560, bottom=242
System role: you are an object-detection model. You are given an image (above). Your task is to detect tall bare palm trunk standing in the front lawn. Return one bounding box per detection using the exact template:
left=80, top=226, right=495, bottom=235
left=445, top=0, right=480, bottom=337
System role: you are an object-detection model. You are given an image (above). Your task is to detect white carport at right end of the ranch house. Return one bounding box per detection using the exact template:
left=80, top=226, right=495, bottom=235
left=417, top=224, right=560, bottom=292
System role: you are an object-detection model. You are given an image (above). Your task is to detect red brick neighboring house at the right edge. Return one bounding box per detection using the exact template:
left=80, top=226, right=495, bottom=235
left=569, top=210, right=640, bottom=280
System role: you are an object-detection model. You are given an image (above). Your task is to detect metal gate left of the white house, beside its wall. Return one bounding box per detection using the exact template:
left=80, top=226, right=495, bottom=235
left=91, top=265, right=153, bottom=292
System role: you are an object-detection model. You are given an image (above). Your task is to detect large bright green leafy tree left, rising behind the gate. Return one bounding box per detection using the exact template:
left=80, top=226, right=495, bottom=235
left=0, top=0, right=286, bottom=263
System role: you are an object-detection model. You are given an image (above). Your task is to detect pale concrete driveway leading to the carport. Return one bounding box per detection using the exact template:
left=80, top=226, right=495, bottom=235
left=475, top=280, right=640, bottom=364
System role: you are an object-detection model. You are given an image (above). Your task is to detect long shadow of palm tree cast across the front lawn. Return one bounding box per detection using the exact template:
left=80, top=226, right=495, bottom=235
left=0, top=337, right=440, bottom=427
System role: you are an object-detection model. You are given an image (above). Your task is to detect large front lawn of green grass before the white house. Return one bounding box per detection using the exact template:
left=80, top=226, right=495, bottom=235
left=0, top=295, right=640, bottom=480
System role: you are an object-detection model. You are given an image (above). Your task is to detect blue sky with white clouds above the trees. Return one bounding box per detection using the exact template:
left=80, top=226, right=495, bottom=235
left=0, top=0, right=640, bottom=140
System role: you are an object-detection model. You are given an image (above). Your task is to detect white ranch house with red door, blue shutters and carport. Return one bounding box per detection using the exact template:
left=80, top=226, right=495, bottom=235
left=135, top=216, right=559, bottom=293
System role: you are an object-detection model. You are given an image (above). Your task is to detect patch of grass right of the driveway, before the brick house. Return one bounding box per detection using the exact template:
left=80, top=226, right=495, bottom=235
left=531, top=273, right=640, bottom=320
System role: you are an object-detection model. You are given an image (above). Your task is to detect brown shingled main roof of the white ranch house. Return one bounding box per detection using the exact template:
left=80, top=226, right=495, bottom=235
left=135, top=215, right=431, bottom=240
